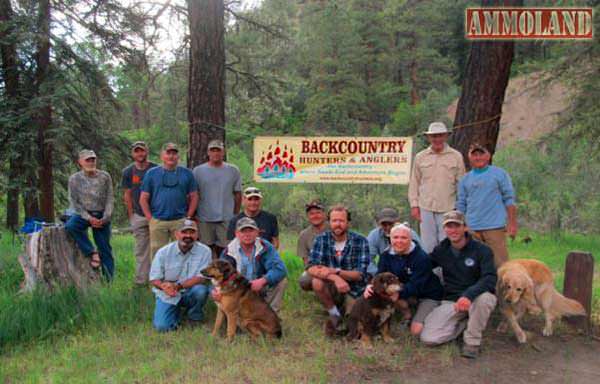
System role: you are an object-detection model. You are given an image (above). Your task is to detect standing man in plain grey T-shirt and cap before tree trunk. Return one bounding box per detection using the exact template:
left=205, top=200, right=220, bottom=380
left=193, top=140, right=242, bottom=258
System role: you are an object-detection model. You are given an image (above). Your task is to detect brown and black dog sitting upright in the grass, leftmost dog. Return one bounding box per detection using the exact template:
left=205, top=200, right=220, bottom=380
left=201, top=260, right=282, bottom=341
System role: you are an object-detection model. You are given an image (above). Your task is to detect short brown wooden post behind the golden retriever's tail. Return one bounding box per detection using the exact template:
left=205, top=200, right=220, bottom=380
left=563, top=251, right=594, bottom=331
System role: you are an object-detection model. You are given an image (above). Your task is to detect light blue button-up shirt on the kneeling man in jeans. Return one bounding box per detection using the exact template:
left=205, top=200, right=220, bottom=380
left=149, top=241, right=212, bottom=305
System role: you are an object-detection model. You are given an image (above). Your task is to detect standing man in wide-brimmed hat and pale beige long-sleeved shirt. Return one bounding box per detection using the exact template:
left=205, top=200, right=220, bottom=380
left=408, top=122, right=465, bottom=253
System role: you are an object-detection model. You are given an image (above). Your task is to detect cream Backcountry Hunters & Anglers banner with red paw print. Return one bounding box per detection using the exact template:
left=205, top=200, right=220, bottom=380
left=254, top=136, right=413, bottom=184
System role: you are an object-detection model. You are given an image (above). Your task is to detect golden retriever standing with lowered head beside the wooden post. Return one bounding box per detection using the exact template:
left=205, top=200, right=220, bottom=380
left=496, top=259, right=586, bottom=343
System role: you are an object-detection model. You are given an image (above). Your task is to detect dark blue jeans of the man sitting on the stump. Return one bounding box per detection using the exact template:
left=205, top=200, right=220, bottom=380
left=65, top=212, right=115, bottom=281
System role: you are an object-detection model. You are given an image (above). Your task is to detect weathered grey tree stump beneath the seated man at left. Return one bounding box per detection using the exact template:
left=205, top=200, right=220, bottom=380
left=19, top=225, right=100, bottom=291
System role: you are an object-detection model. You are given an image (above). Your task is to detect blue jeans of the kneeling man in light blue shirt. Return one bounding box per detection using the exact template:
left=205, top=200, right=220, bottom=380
left=152, top=284, right=210, bottom=332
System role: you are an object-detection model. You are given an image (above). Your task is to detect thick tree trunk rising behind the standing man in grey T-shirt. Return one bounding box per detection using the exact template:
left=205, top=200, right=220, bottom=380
left=188, top=0, right=225, bottom=167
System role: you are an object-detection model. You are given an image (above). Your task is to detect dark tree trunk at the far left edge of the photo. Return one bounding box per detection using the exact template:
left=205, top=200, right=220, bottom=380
left=0, top=0, right=21, bottom=231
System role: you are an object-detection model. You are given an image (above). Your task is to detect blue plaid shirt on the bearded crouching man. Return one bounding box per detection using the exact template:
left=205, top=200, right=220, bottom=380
left=307, top=231, right=371, bottom=297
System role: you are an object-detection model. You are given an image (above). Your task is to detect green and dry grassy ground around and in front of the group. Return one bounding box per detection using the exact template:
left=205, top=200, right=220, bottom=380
left=0, top=230, right=600, bottom=383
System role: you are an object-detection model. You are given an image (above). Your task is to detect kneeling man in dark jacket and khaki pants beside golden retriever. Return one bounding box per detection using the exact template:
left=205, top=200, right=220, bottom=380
left=421, top=211, right=497, bottom=358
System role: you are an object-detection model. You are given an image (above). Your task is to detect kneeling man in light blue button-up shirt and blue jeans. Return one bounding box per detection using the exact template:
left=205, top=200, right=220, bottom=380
left=150, top=220, right=212, bottom=332
